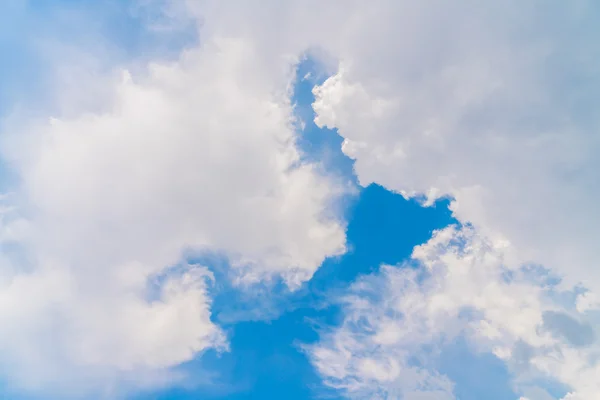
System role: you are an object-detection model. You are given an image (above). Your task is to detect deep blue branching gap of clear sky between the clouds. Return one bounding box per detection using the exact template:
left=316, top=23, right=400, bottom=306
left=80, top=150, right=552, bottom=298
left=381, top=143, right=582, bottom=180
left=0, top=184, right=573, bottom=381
left=140, top=59, right=455, bottom=400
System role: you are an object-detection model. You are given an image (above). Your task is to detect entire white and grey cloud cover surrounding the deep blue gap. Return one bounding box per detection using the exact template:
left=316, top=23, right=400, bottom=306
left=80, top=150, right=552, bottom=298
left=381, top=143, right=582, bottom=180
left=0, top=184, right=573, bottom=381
left=0, top=0, right=600, bottom=400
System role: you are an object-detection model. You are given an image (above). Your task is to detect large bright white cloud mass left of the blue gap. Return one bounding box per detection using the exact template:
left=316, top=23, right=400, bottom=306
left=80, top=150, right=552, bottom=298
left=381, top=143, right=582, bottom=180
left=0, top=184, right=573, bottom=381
left=0, top=11, right=345, bottom=397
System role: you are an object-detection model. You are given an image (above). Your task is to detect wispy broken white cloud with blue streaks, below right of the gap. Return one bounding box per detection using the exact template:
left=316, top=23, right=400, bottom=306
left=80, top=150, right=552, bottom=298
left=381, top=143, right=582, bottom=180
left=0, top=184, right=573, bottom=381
left=308, top=227, right=600, bottom=399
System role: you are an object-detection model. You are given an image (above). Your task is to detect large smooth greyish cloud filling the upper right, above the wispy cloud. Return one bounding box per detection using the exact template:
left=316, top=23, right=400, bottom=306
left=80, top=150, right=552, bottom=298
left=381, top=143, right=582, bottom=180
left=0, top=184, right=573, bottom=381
left=314, top=1, right=600, bottom=291
